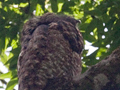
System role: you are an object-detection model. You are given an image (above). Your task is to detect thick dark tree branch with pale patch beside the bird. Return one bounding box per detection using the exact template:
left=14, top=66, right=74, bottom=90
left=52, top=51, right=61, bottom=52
left=75, top=47, right=120, bottom=90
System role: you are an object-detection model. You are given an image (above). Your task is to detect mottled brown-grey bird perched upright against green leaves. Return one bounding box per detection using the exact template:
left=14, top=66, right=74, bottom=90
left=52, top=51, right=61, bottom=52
left=18, top=13, right=83, bottom=90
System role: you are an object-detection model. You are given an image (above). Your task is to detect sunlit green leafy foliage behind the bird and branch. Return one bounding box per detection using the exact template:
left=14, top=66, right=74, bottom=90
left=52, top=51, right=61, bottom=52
left=0, top=0, right=120, bottom=90
